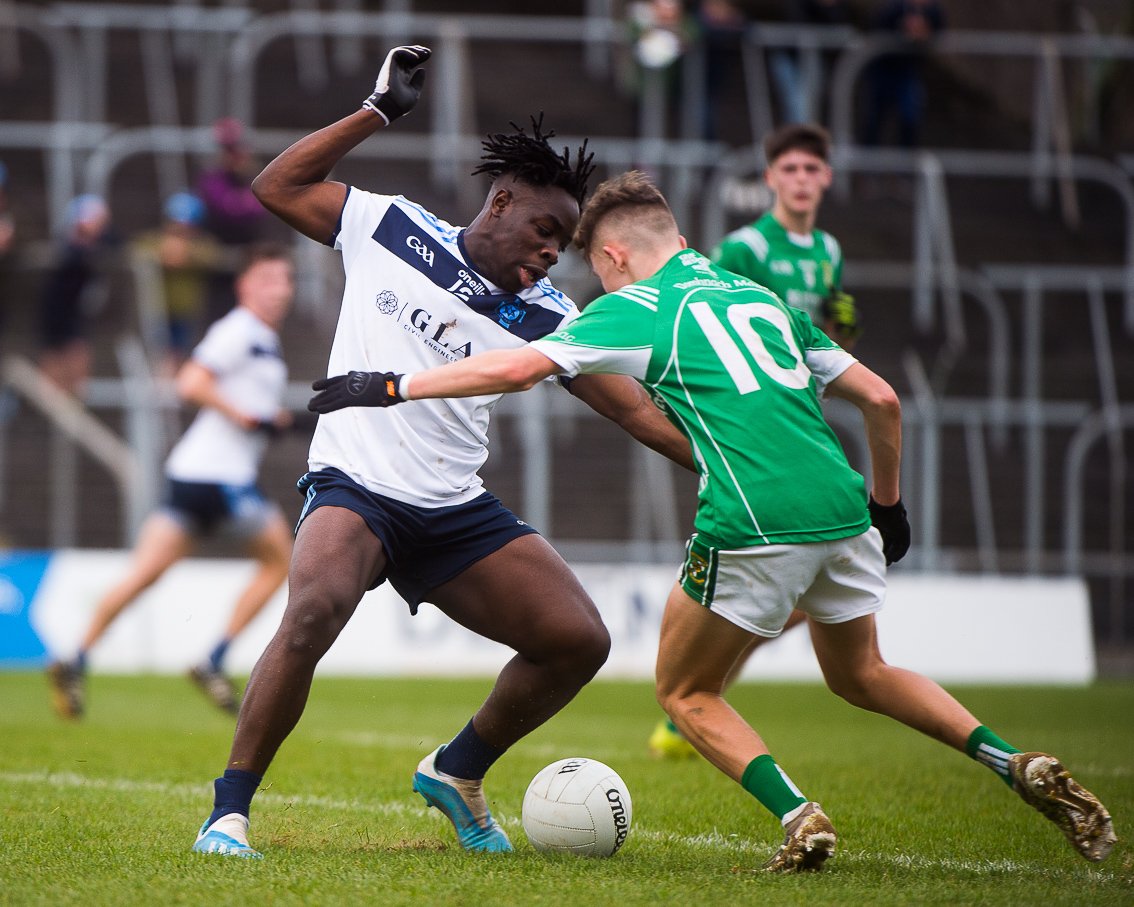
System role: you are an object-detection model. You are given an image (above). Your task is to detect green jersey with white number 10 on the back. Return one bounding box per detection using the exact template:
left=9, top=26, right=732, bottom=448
left=532, top=249, right=870, bottom=549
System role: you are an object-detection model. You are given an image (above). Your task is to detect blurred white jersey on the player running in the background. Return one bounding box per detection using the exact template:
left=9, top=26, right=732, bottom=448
left=166, top=306, right=287, bottom=485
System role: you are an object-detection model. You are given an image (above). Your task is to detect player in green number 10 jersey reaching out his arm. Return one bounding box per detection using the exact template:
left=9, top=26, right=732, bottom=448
left=308, top=171, right=1115, bottom=872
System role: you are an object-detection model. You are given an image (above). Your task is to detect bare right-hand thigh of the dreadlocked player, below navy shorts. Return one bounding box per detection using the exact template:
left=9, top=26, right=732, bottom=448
left=429, top=535, right=602, bottom=655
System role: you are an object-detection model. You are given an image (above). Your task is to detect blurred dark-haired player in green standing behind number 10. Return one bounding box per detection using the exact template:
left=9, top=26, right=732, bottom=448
left=710, top=124, right=862, bottom=349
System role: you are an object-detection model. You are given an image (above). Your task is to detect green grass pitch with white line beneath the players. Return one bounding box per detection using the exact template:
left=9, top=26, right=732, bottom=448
left=0, top=673, right=1134, bottom=907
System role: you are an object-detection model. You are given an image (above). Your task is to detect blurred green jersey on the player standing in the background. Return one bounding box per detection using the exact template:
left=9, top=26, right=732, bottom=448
left=711, top=211, right=843, bottom=325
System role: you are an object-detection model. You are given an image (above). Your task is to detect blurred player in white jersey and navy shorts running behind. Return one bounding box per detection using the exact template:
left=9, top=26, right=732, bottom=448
left=48, top=244, right=295, bottom=718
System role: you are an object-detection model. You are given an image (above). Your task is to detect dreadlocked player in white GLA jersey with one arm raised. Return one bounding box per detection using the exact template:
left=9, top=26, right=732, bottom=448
left=194, top=46, right=692, bottom=857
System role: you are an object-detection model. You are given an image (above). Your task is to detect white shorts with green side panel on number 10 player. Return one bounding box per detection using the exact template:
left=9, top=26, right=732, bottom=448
left=678, top=527, right=886, bottom=636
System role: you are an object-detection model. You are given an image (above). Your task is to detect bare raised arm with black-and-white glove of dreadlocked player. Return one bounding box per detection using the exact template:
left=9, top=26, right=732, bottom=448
left=252, top=45, right=431, bottom=243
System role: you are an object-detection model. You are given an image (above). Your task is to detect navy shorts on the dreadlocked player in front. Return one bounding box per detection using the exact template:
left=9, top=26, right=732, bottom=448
left=296, top=468, right=536, bottom=614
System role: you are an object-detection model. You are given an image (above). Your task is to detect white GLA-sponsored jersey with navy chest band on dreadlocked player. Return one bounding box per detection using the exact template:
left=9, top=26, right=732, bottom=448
left=308, top=188, right=578, bottom=508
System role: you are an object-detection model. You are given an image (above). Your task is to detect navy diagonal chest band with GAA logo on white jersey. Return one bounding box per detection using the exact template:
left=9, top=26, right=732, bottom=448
left=371, top=205, right=566, bottom=341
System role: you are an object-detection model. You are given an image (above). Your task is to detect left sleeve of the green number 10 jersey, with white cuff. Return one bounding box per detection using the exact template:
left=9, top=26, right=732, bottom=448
left=530, top=283, right=658, bottom=380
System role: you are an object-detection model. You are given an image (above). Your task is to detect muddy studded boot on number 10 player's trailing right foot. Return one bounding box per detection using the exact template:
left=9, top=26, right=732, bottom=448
left=1008, top=753, right=1118, bottom=863
